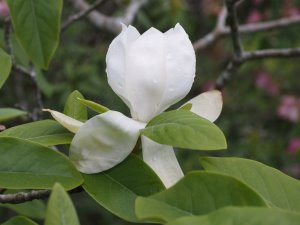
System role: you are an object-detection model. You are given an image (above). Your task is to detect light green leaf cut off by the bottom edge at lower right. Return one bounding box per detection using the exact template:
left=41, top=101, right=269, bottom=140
left=167, top=207, right=300, bottom=225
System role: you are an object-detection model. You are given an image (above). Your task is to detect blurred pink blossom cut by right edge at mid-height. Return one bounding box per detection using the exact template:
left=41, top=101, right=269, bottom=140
left=277, top=95, right=300, bottom=123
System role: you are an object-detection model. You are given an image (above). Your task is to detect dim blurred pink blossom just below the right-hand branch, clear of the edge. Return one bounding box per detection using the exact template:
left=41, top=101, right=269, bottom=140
left=255, top=72, right=279, bottom=97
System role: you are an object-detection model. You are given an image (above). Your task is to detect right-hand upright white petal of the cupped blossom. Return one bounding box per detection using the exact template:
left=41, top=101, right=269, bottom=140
left=160, top=24, right=196, bottom=110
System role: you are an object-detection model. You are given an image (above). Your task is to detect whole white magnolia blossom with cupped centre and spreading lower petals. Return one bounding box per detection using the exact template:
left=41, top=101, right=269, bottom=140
left=45, top=24, right=222, bottom=187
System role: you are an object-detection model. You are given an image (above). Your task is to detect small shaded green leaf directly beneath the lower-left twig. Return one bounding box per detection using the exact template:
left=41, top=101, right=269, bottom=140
left=0, top=200, right=46, bottom=219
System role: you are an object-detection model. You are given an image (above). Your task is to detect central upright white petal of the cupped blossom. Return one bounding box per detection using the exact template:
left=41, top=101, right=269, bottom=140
left=126, top=28, right=166, bottom=122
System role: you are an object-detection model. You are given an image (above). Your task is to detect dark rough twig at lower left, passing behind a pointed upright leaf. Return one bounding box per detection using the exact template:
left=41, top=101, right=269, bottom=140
left=0, top=187, right=83, bottom=204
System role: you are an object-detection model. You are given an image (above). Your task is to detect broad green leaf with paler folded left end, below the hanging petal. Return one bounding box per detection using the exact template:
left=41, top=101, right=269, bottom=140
left=136, top=171, right=266, bottom=223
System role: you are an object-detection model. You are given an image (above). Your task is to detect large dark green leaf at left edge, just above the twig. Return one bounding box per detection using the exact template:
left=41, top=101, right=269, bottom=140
left=0, top=137, right=83, bottom=190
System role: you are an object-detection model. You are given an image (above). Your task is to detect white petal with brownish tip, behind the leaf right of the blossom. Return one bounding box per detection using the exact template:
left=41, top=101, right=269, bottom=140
left=184, top=90, right=223, bottom=122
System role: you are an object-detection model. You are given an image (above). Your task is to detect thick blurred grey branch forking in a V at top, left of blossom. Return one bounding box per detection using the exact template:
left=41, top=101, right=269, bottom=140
left=71, top=0, right=148, bottom=34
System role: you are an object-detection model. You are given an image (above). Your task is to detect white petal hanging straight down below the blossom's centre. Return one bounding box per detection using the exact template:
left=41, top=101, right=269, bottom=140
left=142, top=136, right=184, bottom=188
